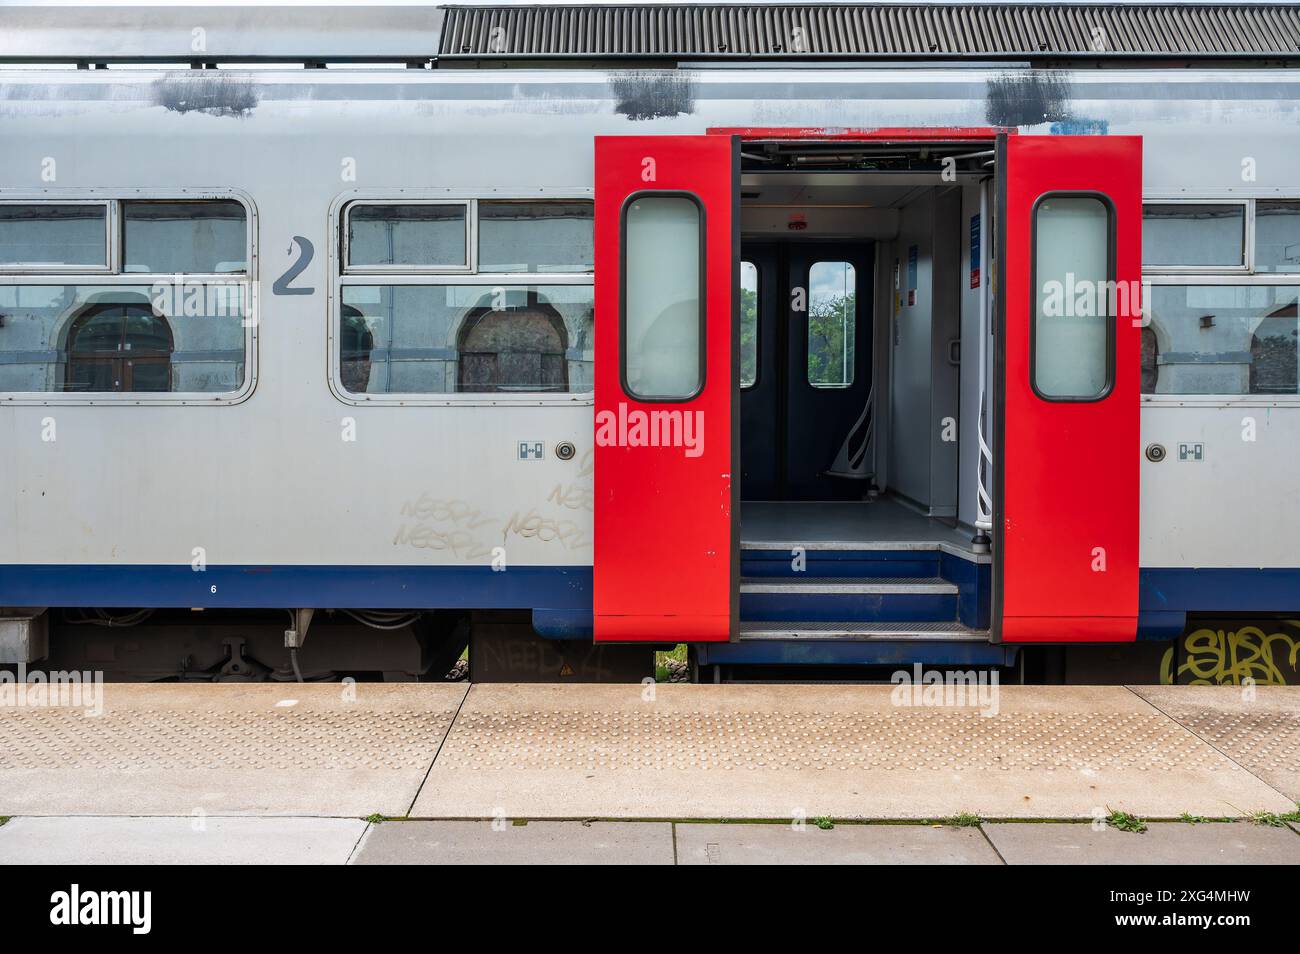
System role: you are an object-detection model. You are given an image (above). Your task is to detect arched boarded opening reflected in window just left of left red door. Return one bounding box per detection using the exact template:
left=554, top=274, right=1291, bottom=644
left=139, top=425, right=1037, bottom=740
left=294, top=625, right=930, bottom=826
left=456, top=290, right=568, bottom=391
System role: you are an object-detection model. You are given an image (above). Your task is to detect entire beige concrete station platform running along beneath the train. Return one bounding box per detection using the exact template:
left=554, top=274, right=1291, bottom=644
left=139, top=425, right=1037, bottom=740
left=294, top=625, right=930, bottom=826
left=0, top=682, right=1300, bottom=862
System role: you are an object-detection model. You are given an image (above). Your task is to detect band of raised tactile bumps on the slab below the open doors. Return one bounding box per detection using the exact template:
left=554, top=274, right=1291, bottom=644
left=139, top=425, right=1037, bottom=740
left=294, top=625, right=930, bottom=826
left=438, top=706, right=1227, bottom=772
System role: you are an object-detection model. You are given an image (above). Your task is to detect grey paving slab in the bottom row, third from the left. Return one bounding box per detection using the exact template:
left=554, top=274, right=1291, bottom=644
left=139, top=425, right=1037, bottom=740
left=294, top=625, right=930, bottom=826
left=676, top=824, right=1002, bottom=864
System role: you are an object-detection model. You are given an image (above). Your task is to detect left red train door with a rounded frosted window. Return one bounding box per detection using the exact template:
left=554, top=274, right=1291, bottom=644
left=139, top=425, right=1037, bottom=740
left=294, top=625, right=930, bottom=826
left=593, top=135, right=740, bottom=642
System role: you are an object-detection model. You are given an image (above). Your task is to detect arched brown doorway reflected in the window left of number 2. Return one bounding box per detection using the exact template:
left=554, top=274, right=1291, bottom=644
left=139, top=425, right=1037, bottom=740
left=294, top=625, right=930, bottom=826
left=64, top=303, right=174, bottom=391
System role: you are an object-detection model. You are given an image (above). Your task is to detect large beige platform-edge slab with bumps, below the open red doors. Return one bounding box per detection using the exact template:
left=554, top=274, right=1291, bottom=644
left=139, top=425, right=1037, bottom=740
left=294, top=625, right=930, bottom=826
left=412, top=685, right=1292, bottom=819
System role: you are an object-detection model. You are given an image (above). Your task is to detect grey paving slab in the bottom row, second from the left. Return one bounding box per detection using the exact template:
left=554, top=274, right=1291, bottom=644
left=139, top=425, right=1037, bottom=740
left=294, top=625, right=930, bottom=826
left=352, top=821, right=673, bottom=864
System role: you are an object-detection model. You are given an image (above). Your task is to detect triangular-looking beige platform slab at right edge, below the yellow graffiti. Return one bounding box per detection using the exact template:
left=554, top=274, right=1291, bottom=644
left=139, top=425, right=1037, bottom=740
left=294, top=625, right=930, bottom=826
left=1134, top=686, right=1300, bottom=802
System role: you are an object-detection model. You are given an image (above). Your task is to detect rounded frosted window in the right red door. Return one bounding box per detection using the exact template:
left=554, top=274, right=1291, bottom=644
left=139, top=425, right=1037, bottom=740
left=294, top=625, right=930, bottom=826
left=1030, top=194, right=1114, bottom=400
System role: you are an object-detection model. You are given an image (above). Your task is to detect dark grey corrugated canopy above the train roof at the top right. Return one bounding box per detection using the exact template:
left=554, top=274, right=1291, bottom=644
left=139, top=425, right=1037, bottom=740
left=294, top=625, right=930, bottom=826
left=439, top=4, right=1300, bottom=60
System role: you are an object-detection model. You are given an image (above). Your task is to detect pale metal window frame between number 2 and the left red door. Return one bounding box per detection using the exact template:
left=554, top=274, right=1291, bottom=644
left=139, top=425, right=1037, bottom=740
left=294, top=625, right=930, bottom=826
left=325, top=188, right=595, bottom=407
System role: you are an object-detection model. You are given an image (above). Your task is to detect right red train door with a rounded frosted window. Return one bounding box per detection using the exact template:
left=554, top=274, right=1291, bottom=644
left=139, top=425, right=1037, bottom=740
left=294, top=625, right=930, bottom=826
left=993, top=135, right=1141, bottom=642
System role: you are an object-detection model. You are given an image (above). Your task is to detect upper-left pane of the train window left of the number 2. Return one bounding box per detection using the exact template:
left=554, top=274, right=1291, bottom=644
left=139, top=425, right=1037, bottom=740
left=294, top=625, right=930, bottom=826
left=0, top=201, right=109, bottom=270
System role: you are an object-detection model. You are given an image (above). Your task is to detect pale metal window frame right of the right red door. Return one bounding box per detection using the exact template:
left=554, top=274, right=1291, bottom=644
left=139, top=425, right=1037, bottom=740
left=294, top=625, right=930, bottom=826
left=1139, top=188, right=1300, bottom=408
